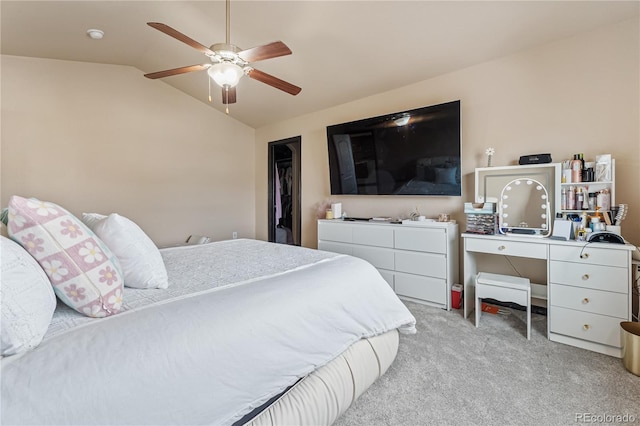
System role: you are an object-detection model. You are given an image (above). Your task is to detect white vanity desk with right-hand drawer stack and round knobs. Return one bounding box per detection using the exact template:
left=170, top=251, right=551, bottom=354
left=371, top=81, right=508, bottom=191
left=462, top=233, right=635, bottom=358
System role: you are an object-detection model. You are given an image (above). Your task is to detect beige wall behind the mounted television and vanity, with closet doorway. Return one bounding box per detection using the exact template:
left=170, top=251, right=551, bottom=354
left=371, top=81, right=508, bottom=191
left=256, top=19, right=640, bottom=247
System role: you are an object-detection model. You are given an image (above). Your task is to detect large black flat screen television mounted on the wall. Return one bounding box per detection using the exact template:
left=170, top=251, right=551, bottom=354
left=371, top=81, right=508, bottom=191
left=327, top=101, right=461, bottom=196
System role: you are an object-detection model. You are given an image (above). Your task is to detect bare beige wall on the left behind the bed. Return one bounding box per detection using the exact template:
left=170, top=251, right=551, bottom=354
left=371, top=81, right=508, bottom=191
left=0, top=56, right=256, bottom=245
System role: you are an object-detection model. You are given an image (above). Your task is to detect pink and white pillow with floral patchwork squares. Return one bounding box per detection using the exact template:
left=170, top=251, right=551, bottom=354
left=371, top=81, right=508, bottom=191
left=7, top=195, right=123, bottom=317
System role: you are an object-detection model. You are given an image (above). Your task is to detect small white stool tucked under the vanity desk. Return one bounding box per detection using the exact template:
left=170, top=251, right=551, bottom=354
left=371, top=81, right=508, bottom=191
left=476, top=272, right=531, bottom=340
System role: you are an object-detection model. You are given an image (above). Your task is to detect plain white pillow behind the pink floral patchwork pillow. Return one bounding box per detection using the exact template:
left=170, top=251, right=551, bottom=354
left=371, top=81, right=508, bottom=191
left=82, top=213, right=169, bottom=288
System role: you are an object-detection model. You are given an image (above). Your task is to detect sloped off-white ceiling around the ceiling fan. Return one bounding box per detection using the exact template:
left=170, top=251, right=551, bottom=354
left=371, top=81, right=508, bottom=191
left=0, top=0, right=640, bottom=128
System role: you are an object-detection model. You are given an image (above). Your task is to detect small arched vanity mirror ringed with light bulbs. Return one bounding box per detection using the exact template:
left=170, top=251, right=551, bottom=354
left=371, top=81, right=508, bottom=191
left=498, top=178, right=550, bottom=237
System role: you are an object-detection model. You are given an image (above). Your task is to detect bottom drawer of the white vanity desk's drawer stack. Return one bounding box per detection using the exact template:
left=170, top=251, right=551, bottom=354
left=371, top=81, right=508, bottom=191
left=549, top=306, right=620, bottom=348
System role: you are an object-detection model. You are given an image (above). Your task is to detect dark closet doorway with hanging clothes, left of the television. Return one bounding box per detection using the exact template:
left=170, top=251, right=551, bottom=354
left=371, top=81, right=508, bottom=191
left=268, top=136, right=302, bottom=246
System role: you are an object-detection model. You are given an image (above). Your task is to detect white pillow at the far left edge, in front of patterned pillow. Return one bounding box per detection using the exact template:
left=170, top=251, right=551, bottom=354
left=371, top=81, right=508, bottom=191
left=0, top=236, right=56, bottom=356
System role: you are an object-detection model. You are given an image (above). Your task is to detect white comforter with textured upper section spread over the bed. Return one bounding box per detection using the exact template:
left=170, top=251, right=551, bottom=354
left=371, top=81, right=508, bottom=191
left=0, top=240, right=415, bottom=425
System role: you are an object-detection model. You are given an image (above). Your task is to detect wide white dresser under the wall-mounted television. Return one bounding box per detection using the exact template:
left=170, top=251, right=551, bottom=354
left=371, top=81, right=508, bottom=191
left=318, top=220, right=458, bottom=310
